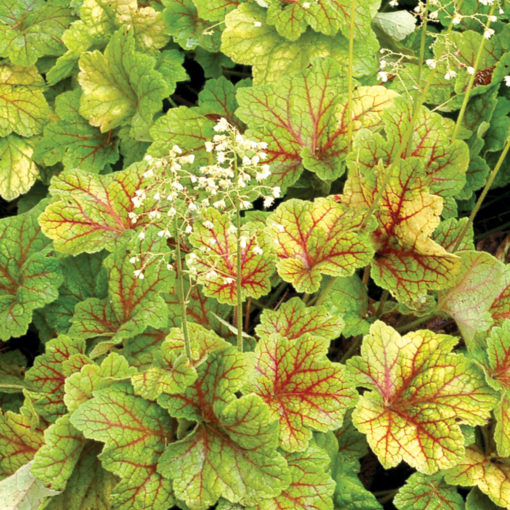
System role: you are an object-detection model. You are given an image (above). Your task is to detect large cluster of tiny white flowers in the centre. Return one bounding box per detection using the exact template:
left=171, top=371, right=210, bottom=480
left=129, top=118, right=274, bottom=279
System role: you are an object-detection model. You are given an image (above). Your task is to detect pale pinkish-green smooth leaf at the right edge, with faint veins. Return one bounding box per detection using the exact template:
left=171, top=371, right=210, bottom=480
left=438, top=251, right=504, bottom=342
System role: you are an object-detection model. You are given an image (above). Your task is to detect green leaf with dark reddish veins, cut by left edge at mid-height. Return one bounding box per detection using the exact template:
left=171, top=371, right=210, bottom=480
left=0, top=203, right=62, bottom=340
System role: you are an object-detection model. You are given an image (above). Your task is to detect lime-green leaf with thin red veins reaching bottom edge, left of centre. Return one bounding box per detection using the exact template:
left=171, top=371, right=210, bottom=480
left=71, top=383, right=174, bottom=510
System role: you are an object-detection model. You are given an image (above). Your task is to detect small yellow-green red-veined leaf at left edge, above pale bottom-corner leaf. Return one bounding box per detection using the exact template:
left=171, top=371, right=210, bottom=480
left=0, top=410, right=43, bottom=478
